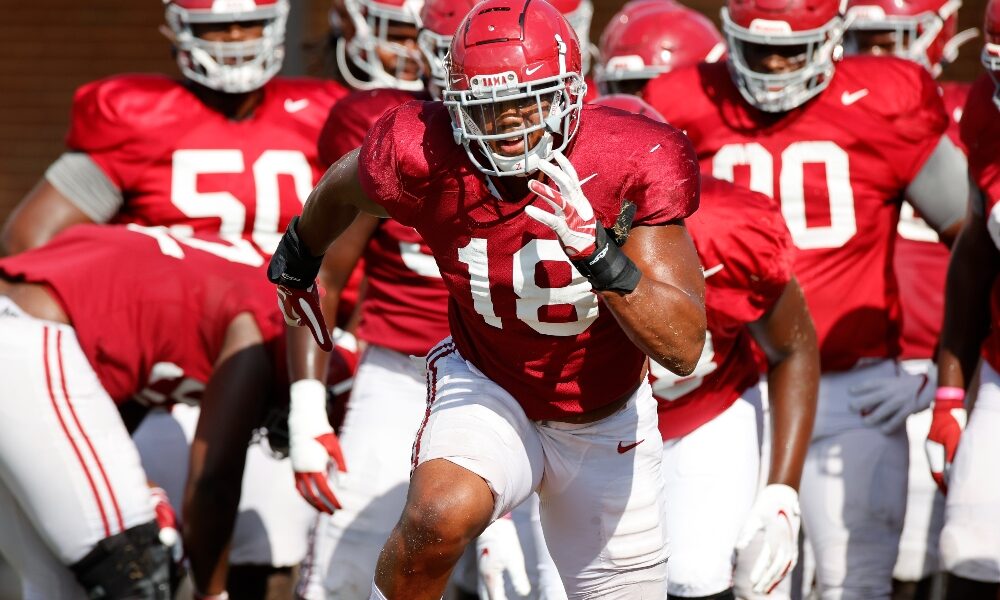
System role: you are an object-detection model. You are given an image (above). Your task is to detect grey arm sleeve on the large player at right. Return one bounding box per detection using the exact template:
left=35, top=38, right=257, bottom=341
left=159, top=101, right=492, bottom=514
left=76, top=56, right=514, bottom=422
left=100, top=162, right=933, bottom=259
left=906, top=135, right=969, bottom=231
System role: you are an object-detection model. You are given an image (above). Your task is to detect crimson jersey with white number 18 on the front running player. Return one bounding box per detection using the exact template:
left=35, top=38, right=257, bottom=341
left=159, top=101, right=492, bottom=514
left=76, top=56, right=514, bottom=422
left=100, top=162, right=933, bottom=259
left=359, top=102, right=698, bottom=420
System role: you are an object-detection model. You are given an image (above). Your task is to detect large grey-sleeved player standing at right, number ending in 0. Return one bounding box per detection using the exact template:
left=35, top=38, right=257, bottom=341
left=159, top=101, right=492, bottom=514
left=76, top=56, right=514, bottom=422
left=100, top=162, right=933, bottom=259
left=644, top=0, right=968, bottom=599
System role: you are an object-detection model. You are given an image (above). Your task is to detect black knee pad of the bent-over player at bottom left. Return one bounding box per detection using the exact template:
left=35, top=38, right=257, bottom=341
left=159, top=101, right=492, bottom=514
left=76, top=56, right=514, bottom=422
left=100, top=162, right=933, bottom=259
left=70, top=522, right=173, bottom=600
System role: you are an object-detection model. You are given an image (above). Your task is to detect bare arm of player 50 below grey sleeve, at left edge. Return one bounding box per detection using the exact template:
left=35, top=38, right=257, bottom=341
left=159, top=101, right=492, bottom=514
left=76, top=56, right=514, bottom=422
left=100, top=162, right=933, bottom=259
left=0, top=179, right=94, bottom=255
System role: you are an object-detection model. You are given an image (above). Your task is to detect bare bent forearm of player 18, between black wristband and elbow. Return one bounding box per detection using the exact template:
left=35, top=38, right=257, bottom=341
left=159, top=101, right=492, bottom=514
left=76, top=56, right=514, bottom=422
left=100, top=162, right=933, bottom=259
left=600, top=277, right=705, bottom=376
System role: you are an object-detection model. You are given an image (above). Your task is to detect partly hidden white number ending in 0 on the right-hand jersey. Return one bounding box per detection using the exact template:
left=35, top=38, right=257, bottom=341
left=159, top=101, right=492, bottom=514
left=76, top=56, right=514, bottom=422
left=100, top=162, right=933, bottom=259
left=712, top=141, right=858, bottom=250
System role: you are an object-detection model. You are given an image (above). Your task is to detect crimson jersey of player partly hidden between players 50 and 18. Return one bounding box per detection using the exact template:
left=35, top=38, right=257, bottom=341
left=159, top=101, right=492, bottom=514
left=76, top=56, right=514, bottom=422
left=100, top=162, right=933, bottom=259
left=319, top=89, right=448, bottom=356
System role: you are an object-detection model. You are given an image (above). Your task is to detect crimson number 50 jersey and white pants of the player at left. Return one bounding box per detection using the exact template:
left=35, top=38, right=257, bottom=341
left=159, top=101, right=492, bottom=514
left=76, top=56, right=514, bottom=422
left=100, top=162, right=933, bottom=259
left=60, top=75, right=345, bottom=566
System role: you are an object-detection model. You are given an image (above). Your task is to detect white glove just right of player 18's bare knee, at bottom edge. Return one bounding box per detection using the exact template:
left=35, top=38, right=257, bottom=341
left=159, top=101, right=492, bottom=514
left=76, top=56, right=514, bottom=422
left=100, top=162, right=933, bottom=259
left=476, top=515, right=531, bottom=600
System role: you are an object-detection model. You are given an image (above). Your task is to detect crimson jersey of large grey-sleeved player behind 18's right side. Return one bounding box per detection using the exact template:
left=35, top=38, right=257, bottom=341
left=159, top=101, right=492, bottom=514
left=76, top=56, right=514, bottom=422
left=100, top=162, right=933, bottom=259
left=644, top=56, right=947, bottom=371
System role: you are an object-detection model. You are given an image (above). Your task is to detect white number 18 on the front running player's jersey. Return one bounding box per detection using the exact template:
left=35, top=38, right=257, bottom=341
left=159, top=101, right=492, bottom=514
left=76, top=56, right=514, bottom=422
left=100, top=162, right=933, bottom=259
left=458, top=238, right=598, bottom=336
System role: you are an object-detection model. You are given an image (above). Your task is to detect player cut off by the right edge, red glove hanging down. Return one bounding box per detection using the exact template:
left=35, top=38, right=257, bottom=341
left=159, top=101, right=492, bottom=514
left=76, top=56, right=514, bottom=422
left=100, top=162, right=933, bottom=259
left=927, top=0, right=1000, bottom=599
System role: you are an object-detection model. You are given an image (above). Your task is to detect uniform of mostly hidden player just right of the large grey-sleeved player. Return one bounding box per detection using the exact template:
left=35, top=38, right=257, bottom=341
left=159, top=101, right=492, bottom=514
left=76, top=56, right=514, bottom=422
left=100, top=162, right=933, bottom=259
left=893, top=81, right=971, bottom=581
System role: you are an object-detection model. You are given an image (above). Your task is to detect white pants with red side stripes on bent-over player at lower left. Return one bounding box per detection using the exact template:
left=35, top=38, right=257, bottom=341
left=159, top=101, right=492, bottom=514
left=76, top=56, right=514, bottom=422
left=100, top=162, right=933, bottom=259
left=0, top=298, right=154, bottom=598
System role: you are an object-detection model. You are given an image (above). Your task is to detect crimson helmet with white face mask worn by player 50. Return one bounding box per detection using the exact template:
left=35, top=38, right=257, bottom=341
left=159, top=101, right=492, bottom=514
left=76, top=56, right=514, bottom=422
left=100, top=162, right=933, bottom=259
left=163, top=0, right=288, bottom=94
